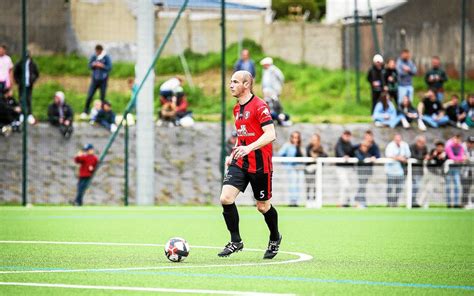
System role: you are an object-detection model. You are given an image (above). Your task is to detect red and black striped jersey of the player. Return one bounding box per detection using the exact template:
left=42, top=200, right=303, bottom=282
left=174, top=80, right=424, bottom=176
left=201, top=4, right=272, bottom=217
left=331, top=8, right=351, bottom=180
left=232, top=95, right=273, bottom=173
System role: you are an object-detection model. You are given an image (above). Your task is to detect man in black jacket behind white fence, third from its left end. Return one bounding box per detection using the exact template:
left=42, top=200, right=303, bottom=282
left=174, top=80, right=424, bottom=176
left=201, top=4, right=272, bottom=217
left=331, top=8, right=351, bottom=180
left=335, top=130, right=355, bottom=207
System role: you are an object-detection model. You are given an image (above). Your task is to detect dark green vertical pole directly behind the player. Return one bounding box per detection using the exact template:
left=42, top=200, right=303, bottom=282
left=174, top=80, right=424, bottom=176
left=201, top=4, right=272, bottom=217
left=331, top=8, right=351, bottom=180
left=220, top=0, right=226, bottom=179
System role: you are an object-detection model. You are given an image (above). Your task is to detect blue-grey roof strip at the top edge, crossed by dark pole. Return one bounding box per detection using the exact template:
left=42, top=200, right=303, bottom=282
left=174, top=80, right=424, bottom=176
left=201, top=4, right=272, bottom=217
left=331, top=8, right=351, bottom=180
left=153, top=0, right=265, bottom=11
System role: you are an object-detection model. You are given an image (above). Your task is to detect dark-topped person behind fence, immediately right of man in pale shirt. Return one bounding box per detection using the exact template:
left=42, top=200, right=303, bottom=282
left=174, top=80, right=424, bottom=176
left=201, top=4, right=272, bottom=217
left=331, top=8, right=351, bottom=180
left=410, top=135, right=428, bottom=208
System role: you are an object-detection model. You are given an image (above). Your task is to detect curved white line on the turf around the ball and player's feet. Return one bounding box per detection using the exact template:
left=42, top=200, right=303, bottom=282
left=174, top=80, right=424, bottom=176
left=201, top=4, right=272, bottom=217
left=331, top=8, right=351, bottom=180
left=0, top=241, right=313, bottom=274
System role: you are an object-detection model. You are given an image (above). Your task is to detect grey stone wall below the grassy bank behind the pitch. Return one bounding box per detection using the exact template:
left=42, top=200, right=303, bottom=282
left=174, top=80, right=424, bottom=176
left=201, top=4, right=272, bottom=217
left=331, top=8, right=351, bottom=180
left=0, top=123, right=468, bottom=205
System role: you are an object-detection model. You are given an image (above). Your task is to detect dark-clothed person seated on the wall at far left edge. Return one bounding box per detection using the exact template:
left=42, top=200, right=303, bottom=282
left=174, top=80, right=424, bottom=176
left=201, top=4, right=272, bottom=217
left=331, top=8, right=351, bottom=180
left=0, top=93, right=23, bottom=136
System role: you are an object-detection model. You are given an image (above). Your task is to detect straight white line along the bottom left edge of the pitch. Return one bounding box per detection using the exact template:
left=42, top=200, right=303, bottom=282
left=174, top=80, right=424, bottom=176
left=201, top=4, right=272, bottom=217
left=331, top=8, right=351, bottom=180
left=0, top=282, right=294, bottom=296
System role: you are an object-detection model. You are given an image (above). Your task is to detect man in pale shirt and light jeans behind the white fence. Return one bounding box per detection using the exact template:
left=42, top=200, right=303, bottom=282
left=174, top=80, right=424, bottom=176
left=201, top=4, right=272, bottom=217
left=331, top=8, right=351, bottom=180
left=385, top=134, right=411, bottom=207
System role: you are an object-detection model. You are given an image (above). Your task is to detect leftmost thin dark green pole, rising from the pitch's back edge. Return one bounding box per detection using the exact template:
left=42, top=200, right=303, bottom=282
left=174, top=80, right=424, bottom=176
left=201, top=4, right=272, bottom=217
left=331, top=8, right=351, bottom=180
left=20, top=0, right=28, bottom=206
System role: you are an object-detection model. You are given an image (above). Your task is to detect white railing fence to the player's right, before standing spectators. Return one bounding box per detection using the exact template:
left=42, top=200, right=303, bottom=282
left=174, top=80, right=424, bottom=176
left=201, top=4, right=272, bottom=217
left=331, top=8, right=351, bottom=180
left=237, top=157, right=474, bottom=208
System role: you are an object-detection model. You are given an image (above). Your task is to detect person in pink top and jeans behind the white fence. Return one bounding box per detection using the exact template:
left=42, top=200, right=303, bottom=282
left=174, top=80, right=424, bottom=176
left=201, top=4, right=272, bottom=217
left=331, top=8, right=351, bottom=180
left=445, top=134, right=466, bottom=208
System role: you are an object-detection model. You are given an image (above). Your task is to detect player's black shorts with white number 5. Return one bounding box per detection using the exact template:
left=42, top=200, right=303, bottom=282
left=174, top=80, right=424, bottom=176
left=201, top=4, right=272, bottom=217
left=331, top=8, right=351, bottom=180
left=222, top=165, right=272, bottom=201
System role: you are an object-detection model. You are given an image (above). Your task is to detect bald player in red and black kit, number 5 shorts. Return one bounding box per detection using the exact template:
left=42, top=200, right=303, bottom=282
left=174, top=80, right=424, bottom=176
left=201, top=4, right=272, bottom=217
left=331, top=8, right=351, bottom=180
left=218, top=71, right=282, bottom=259
